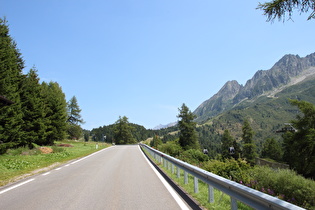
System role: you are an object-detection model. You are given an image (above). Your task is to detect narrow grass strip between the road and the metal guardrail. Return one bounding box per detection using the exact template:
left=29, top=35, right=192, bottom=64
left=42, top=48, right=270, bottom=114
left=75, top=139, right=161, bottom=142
left=144, top=150, right=252, bottom=210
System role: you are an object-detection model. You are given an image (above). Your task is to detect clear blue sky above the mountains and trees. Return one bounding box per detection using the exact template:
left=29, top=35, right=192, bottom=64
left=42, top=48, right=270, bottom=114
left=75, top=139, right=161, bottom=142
left=0, top=0, right=315, bottom=129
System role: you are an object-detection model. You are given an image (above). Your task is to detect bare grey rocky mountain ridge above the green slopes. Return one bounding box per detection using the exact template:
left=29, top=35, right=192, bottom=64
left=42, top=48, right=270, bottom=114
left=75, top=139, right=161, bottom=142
left=194, top=53, right=315, bottom=122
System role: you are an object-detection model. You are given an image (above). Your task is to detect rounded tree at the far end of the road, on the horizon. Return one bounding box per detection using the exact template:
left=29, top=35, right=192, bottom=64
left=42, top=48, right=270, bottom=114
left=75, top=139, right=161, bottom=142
left=114, top=116, right=136, bottom=144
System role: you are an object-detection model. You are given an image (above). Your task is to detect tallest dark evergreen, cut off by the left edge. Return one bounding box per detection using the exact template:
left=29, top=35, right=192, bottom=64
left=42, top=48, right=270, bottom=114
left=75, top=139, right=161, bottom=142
left=0, top=18, right=24, bottom=153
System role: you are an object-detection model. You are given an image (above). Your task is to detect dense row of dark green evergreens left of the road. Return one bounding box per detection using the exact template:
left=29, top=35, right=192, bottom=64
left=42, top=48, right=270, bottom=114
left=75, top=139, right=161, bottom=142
left=0, top=19, right=83, bottom=154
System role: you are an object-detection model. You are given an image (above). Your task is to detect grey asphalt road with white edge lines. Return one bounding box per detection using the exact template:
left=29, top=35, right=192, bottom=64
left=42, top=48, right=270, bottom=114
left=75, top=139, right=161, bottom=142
left=0, top=145, right=190, bottom=210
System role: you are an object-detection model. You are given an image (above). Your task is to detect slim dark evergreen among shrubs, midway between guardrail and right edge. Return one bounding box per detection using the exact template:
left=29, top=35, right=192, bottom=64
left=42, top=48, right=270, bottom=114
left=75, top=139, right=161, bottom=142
left=242, top=120, right=256, bottom=164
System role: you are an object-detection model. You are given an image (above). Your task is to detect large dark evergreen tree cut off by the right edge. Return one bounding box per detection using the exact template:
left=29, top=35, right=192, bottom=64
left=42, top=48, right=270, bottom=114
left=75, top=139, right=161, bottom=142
left=283, top=100, right=315, bottom=179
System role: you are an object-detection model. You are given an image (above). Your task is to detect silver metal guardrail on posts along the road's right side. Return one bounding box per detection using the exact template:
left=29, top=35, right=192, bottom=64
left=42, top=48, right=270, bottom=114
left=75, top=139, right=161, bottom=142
left=140, top=144, right=303, bottom=210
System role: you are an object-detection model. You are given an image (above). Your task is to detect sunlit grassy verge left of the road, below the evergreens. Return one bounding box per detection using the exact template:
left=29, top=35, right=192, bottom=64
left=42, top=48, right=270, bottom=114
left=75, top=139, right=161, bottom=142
left=0, top=141, right=108, bottom=186
